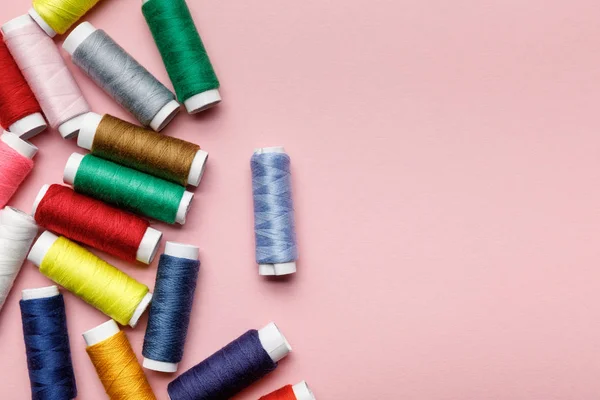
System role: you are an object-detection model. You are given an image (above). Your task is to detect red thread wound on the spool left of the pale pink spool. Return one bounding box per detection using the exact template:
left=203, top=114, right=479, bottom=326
left=0, top=40, right=42, bottom=133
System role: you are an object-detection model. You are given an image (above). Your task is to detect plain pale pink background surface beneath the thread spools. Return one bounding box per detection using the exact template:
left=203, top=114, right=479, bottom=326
left=0, top=0, right=600, bottom=400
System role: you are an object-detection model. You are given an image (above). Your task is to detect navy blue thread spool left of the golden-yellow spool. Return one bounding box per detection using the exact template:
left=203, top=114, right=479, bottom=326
left=19, top=286, right=77, bottom=400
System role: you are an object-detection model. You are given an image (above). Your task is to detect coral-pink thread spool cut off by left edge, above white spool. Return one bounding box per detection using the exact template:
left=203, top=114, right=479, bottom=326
left=0, top=132, right=38, bottom=208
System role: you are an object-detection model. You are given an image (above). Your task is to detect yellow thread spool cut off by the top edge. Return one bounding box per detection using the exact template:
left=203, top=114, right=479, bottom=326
left=29, top=0, right=100, bottom=37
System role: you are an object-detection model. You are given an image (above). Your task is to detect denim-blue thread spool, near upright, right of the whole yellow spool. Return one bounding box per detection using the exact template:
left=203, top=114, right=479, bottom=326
left=142, top=242, right=200, bottom=372
